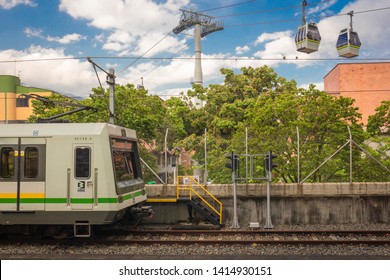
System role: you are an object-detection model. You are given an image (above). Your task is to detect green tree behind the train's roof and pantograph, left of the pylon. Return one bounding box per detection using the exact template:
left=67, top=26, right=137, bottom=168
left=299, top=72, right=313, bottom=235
left=29, top=84, right=166, bottom=142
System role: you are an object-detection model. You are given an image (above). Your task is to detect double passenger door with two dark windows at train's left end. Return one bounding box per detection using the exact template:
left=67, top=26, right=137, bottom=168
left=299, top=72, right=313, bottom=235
left=0, top=137, right=46, bottom=212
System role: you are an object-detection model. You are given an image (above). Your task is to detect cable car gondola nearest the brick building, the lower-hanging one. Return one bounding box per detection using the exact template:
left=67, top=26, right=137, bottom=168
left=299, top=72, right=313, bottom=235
left=336, top=11, right=361, bottom=58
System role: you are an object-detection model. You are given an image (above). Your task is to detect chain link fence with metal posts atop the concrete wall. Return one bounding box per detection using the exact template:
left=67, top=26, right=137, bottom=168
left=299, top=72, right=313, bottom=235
left=140, top=127, right=390, bottom=184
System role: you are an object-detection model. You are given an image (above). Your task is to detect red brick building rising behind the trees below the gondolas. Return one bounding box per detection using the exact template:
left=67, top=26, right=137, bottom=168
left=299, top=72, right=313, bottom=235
left=324, top=62, right=390, bottom=125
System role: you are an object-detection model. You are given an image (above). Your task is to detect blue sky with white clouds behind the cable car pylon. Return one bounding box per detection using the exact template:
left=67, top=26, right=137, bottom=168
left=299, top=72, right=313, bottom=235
left=0, top=0, right=390, bottom=98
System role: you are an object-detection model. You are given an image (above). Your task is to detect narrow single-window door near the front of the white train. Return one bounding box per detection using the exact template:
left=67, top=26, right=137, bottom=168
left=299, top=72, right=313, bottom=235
left=70, top=144, right=94, bottom=210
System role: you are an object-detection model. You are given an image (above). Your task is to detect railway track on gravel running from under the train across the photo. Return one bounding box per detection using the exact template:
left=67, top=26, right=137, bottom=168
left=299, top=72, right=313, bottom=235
left=0, top=229, right=390, bottom=246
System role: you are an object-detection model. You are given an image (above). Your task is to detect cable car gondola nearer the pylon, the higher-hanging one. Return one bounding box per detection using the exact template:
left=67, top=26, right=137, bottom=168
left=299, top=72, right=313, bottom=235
left=295, top=0, right=321, bottom=53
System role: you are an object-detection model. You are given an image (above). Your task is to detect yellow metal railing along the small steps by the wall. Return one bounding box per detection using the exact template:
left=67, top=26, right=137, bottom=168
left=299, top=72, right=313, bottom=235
left=176, top=176, right=222, bottom=224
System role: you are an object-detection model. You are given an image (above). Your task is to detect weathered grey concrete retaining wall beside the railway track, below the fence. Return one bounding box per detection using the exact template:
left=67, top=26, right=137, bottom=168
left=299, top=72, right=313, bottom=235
left=147, top=183, right=390, bottom=227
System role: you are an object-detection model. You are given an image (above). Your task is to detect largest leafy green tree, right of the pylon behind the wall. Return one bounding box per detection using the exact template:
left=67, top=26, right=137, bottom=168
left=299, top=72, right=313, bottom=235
left=175, top=66, right=367, bottom=182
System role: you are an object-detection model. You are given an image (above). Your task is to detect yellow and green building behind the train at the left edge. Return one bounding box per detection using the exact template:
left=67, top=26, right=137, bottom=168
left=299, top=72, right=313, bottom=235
left=0, top=75, right=53, bottom=124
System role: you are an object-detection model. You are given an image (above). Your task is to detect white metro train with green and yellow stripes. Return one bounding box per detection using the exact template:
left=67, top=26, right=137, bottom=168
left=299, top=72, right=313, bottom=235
left=0, top=123, right=146, bottom=236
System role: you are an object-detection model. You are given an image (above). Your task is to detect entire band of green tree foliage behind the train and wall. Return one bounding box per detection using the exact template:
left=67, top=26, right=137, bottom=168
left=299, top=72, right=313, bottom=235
left=32, top=66, right=390, bottom=183
